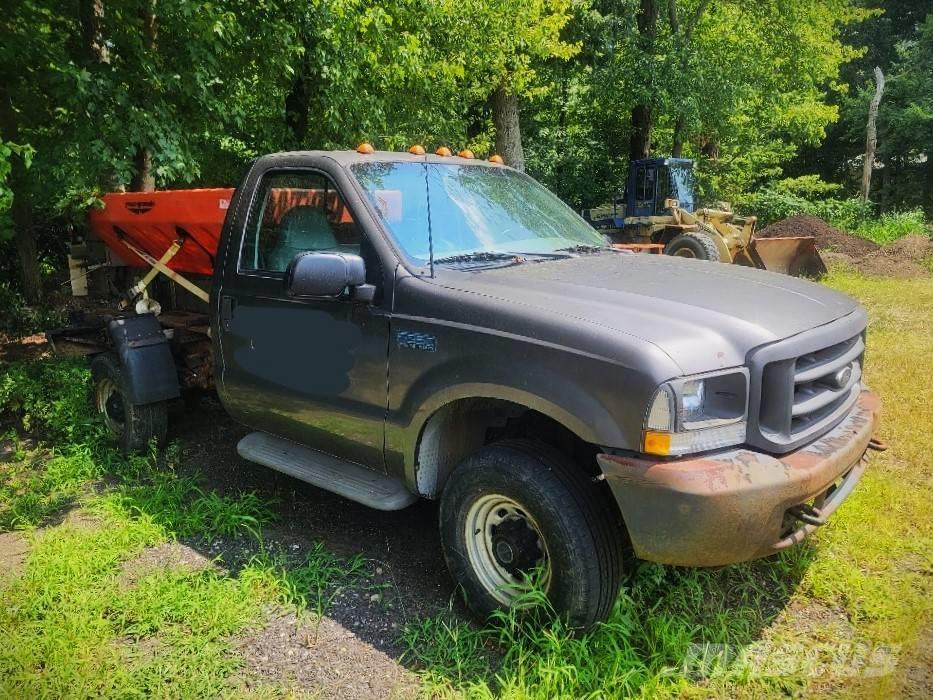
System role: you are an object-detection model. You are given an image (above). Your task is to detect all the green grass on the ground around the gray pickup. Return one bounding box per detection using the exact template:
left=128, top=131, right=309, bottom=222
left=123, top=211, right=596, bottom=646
left=0, top=272, right=933, bottom=698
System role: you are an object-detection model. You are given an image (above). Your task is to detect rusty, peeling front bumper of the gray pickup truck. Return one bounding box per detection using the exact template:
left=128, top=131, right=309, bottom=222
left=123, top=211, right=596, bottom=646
left=597, top=391, right=878, bottom=566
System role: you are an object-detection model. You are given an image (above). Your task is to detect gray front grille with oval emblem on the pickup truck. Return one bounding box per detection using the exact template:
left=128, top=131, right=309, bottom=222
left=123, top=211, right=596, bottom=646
left=747, top=310, right=866, bottom=452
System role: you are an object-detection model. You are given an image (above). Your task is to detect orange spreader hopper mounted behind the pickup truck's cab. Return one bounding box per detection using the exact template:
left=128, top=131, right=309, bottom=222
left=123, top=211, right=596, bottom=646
left=88, top=188, right=233, bottom=275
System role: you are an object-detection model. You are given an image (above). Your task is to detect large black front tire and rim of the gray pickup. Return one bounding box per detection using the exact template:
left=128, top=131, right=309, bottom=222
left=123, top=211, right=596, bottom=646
left=440, top=440, right=624, bottom=629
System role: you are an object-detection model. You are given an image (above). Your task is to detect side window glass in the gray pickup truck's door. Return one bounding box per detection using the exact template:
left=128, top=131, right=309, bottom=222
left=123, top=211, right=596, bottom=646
left=239, top=172, right=360, bottom=273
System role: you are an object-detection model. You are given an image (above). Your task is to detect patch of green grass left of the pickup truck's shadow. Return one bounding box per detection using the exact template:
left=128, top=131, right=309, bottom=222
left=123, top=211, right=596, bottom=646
left=0, top=360, right=378, bottom=698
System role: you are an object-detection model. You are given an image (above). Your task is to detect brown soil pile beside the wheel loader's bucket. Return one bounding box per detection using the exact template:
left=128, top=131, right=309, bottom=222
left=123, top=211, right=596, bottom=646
left=755, top=215, right=933, bottom=278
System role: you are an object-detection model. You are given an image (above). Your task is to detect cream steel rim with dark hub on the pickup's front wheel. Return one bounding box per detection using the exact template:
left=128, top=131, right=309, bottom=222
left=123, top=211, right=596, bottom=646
left=464, top=494, right=551, bottom=605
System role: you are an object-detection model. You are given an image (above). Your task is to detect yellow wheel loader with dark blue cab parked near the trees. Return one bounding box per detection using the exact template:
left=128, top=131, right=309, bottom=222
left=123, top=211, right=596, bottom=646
left=583, top=158, right=826, bottom=277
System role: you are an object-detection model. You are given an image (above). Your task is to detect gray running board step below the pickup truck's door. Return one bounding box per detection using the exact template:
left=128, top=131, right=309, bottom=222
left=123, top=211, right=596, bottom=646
left=236, top=432, right=418, bottom=510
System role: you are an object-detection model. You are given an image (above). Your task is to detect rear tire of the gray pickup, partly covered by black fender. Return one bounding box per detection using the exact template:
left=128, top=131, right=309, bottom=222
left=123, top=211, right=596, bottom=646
left=91, top=352, right=168, bottom=454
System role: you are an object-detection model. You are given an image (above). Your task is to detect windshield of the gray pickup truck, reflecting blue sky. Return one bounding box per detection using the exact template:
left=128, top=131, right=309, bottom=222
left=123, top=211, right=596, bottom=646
left=352, top=161, right=607, bottom=263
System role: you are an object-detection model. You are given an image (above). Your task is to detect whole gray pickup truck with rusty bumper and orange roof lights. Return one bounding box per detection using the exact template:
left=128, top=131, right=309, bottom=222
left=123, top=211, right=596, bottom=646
left=71, top=149, right=878, bottom=628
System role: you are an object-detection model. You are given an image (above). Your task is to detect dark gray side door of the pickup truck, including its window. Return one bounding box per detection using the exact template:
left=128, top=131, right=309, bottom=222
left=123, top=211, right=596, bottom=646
left=215, top=169, right=389, bottom=471
